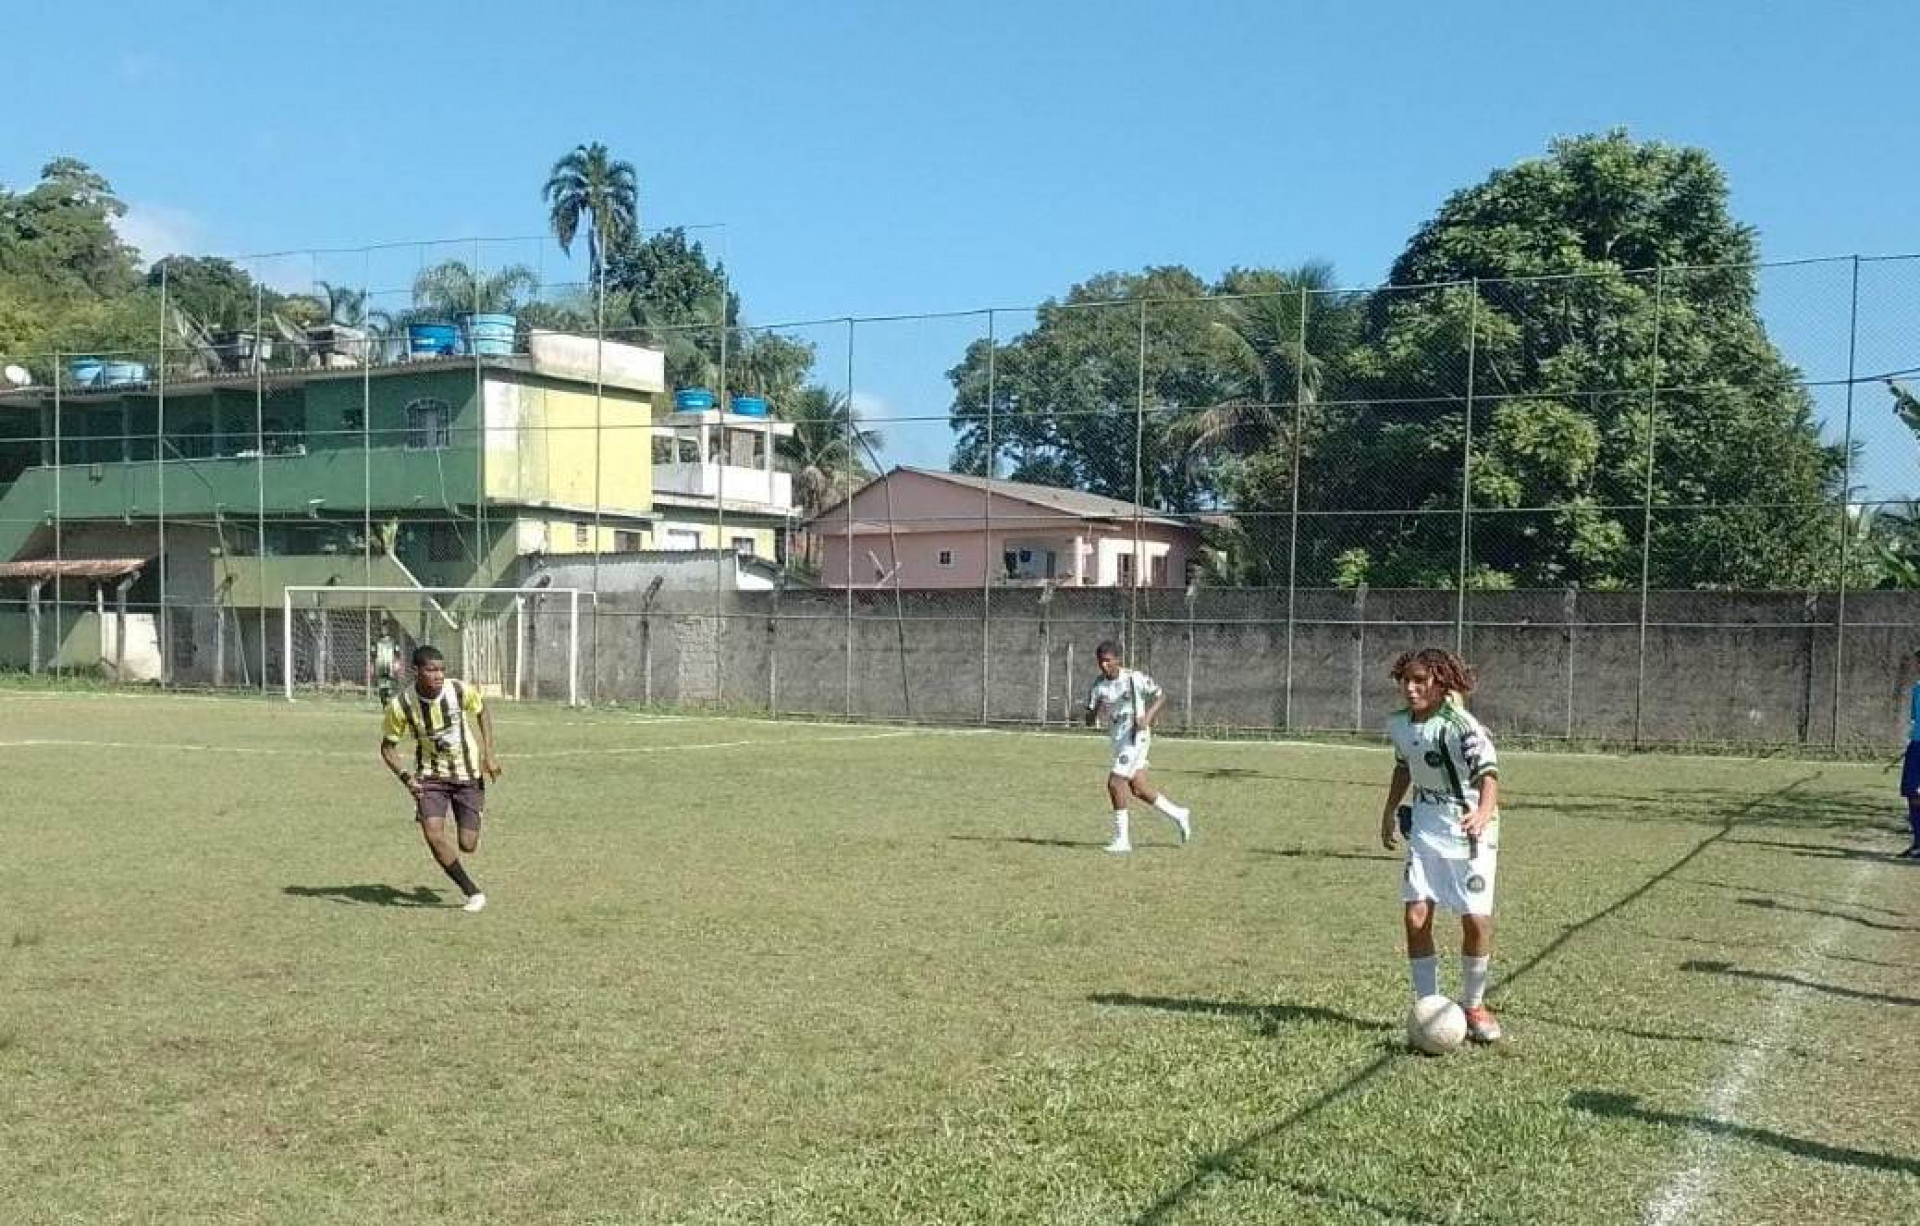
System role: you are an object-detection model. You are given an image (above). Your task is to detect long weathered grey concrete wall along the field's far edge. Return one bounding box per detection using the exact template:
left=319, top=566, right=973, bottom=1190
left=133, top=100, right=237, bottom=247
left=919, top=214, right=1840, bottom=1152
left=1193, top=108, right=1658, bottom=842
left=536, top=589, right=1920, bottom=748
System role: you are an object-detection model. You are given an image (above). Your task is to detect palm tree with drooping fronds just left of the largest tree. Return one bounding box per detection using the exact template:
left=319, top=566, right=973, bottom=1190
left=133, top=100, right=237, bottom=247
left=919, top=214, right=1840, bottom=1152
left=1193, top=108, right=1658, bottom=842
left=1173, top=263, right=1359, bottom=462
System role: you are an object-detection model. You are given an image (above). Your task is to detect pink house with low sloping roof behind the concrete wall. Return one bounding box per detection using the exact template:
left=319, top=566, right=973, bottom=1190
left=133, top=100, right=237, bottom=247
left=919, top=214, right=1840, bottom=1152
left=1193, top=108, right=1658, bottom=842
left=806, top=468, right=1200, bottom=587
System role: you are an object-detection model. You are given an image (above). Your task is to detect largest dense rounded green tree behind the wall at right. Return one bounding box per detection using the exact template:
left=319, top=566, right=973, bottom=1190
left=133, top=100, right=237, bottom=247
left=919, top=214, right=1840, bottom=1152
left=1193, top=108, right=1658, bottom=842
left=1242, top=132, right=1843, bottom=587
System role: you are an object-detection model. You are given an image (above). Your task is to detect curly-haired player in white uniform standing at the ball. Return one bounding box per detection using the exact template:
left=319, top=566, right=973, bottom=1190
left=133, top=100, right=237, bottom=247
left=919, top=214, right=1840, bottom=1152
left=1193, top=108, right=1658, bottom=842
left=1380, top=647, right=1501, bottom=1044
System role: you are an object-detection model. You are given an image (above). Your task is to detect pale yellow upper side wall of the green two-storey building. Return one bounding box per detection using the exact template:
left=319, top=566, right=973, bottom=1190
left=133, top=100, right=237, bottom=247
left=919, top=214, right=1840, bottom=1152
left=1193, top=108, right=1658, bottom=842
left=486, top=370, right=653, bottom=514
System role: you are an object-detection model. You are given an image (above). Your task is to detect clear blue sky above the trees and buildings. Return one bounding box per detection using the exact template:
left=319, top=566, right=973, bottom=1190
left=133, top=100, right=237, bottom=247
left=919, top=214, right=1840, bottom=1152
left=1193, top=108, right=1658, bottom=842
left=0, top=0, right=1920, bottom=485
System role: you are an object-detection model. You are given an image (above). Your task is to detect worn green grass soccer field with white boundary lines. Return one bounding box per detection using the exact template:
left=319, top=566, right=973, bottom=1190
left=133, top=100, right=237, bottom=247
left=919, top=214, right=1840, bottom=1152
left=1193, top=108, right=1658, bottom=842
left=0, top=693, right=1920, bottom=1224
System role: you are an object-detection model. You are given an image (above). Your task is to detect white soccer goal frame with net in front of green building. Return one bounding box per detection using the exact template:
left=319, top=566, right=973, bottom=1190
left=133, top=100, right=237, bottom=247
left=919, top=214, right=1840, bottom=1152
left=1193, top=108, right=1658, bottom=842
left=280, top=583, right=599, bottom=706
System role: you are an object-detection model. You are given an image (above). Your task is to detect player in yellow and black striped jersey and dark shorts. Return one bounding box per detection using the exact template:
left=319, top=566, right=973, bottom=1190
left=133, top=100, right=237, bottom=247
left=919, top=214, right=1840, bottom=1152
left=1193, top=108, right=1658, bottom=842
left=380, top=647, right=499, bottom=911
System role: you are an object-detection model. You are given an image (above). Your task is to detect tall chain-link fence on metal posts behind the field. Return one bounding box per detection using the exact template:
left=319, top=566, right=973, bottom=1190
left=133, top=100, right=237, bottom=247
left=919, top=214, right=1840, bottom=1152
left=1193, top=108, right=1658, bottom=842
left=0, top=244, right=1920, bottom=748
